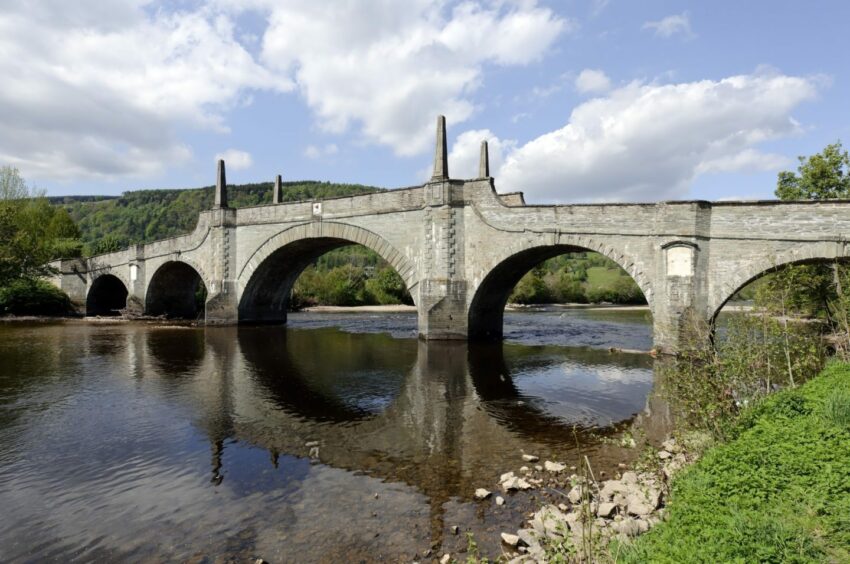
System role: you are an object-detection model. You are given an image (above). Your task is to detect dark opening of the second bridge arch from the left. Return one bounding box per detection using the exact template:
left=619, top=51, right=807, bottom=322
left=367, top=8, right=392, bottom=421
left=145, top=260, right=207, bottom=319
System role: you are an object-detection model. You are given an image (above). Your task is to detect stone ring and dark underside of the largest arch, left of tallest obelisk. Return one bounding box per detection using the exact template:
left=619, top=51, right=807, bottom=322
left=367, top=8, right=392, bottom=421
left=239, top=222, right=418, bottom=323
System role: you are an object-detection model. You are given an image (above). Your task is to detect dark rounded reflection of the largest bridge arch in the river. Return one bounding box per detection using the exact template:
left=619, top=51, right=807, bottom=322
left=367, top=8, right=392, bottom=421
left=237, top=326, right=416, bottom=423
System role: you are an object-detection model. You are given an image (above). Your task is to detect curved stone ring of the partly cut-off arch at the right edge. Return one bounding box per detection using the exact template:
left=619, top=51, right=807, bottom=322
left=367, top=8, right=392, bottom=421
left=709, top=244, right=850, bottom=327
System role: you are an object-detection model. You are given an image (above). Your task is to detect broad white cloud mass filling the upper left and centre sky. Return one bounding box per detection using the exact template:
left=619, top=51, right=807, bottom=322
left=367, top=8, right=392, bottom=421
left=0, top=0, right=575, bottom=179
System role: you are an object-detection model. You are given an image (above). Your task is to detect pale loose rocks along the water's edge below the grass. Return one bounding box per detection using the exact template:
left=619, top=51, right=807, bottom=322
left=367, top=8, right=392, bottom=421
left=475, top=438, right=697, bottom=564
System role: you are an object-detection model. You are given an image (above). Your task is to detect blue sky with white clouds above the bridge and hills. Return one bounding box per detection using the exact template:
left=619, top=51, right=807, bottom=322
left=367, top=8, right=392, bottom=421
left=0, top=0, right=850, bottom=203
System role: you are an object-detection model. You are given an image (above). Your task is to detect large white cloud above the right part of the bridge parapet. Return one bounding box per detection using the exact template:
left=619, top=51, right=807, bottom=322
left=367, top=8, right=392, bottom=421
left=494, top=73, right=817, bottom=202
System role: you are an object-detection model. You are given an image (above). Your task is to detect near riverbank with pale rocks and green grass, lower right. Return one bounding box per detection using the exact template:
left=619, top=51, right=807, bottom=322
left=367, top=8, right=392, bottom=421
left=484, top=362, right=850, bottom=563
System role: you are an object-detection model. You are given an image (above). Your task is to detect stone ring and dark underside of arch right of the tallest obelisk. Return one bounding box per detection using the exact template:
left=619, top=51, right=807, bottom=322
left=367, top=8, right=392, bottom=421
left=467, top=236, right=653, bottom=341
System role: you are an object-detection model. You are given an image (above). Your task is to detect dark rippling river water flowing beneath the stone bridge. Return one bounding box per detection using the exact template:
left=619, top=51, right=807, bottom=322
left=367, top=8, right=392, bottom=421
left=0, top=310, right=669, bottom=562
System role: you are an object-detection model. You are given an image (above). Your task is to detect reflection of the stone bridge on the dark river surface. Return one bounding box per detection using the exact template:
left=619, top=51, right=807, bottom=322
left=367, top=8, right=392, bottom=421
left=142, top=327, right=669, bottom=540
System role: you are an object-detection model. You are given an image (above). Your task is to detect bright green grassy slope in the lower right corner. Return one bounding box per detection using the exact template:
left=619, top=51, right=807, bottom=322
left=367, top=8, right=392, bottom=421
left=619, top=363, right=850, bottom=563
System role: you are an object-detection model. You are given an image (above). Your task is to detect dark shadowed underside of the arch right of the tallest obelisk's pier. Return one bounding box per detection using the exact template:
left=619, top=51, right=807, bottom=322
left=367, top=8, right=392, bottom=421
left=467, top=244, right=652, bottom=341
